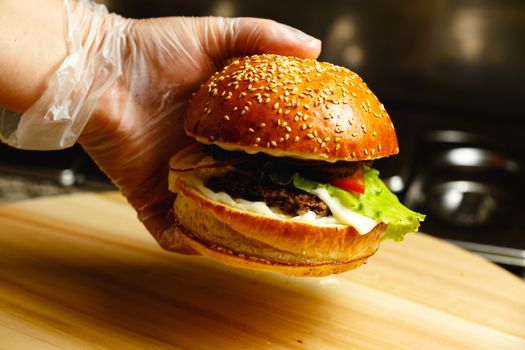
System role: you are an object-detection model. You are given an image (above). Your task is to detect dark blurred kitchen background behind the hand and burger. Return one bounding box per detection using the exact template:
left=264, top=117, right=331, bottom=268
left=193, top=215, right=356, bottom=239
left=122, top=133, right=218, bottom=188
left=0, top=0, right=525, bottom=277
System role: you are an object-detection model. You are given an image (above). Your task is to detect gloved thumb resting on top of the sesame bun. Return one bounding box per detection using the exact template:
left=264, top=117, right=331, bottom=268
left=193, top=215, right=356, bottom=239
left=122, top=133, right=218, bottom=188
left=197, top=17, right=321, bottom=63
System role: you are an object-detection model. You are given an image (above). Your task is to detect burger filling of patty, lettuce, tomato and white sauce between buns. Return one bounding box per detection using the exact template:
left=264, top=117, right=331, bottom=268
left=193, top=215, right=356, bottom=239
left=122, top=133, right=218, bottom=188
left=172, top=146, right=424, bottom=240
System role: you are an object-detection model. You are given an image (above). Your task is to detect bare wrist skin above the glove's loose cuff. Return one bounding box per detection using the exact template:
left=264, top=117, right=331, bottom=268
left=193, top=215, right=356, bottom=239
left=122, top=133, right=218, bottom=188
left=0, top=0, right=67, bottom=112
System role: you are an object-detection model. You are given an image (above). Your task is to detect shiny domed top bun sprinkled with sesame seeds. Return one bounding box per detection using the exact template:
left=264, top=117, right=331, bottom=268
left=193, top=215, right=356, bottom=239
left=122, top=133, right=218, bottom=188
left=185, top=55, right=399, bottom=162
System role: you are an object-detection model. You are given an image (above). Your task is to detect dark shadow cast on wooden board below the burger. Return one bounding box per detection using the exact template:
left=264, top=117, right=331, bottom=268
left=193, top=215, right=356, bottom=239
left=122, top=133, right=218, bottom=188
left=0, top=237, right=352, bottom=347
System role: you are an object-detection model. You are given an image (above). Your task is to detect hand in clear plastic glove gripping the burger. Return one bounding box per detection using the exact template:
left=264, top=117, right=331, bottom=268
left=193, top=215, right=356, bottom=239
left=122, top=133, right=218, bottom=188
left=7, top=1, right=320, bottom=252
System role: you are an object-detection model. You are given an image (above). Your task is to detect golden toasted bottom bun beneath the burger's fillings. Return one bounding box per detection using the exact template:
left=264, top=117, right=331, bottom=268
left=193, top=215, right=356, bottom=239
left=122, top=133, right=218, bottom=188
left=170, top=177, right=386, bottom=276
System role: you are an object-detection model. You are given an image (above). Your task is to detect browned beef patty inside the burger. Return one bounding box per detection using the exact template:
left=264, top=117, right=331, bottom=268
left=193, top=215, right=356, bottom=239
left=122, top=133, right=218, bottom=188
left=206, top=172, right=331, bottom=216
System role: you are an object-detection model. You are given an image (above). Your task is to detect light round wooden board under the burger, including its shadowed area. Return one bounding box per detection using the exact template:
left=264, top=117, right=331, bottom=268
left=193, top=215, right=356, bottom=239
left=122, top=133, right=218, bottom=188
left=0, top=193, right=525, bottom=350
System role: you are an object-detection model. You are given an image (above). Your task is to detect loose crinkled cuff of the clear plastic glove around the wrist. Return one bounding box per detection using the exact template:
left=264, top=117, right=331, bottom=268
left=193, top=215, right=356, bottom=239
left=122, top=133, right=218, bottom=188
left=0, top=0, right=133, bottom=150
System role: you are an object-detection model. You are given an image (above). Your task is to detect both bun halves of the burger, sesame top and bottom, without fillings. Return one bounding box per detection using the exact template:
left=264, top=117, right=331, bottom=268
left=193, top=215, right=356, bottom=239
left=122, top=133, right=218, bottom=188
left=169, top=55, right=399, bottom=276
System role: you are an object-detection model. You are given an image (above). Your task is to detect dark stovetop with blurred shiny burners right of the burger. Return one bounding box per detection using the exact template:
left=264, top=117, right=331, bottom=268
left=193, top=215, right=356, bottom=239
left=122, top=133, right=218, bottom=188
left=377, top=111, right=525, bottom=276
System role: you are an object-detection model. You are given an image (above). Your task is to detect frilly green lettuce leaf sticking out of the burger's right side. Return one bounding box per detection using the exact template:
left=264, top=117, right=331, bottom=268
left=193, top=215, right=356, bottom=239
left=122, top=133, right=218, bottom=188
left=270, top=166, right=425, bottom=241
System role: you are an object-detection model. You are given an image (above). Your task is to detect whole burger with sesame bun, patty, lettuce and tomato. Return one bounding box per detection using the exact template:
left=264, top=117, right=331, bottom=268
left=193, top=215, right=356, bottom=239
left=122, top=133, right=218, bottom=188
left=169, top=55, right=424, bottom=276
